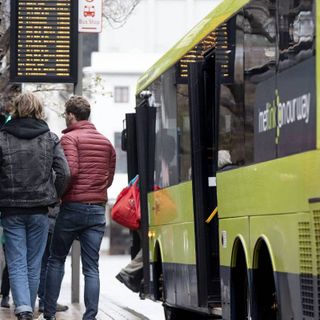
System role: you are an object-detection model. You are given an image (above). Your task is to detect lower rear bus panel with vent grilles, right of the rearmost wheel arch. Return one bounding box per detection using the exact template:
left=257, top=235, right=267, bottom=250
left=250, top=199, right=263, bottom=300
left=250, top=212, right=318, bottom=319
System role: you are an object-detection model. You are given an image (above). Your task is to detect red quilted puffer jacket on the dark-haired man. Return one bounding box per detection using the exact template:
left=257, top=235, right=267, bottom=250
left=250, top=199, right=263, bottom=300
left=61, top=120, right=116, bottom=203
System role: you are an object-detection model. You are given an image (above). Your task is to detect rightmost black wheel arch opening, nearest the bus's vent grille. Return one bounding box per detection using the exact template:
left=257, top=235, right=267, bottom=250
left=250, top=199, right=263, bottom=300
left=252, top=237, right=279, bottom=320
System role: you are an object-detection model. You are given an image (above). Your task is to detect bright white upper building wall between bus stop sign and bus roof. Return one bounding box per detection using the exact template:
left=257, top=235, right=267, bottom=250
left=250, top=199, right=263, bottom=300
left=99, top=0, right=221, bottom=53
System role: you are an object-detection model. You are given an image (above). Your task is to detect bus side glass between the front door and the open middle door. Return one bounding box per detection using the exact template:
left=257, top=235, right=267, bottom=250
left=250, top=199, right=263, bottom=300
left=149, top=67, right=191, bottom=188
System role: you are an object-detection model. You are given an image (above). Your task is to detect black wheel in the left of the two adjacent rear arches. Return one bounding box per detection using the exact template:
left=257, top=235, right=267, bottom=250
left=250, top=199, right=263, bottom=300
left=231, top=246, right=250, bottom=320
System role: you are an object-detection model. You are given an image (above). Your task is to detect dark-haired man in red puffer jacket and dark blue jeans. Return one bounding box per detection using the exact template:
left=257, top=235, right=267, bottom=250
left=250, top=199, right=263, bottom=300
left=40, top=96, right=116, bottom=320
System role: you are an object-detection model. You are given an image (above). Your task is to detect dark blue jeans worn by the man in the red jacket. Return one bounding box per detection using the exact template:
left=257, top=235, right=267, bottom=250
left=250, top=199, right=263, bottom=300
left=44, top=202, right=106, bottom=320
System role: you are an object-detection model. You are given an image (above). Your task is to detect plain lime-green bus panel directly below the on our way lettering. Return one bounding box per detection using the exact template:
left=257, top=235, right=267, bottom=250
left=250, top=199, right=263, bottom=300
left=217, top=150, right=320, bottom=219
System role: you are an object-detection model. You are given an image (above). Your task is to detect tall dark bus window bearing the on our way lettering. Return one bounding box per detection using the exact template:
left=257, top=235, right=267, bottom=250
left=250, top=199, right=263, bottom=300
left=277, top=0, right=316, bottom=157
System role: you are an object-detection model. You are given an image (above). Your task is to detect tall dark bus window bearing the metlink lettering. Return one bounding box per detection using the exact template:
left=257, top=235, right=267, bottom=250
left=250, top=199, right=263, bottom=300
left=243, top=0, right=277, bottom=163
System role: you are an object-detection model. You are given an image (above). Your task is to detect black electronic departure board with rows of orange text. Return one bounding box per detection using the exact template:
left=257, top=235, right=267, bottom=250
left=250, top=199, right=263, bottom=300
left=10, top=0, right=78, bottom=83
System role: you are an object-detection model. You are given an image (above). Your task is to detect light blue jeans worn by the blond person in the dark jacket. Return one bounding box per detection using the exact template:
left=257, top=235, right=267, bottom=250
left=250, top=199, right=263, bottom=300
left=1, top=214, right=48, bottom=314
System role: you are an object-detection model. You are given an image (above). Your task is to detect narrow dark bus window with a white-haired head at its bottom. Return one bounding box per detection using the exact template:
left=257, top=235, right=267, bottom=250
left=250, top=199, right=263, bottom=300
left=217, top=15, right=245, bottom=168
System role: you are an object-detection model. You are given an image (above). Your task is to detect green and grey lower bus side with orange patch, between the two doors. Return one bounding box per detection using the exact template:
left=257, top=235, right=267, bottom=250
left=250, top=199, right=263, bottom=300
left=148, top=181, right=198, bottom=308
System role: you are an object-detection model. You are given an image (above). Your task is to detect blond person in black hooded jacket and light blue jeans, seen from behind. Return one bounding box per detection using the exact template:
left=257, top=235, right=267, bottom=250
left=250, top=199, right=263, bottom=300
left=0, top=92, right=70, bottom=320
